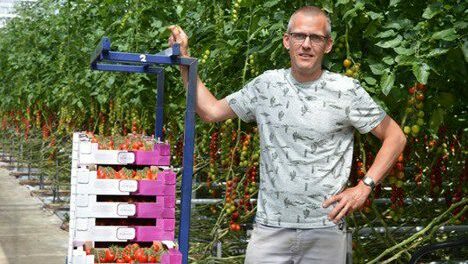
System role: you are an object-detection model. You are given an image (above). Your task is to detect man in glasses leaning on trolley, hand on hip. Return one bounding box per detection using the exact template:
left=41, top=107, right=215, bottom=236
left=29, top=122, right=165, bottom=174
left=169, top=6, right=406, bottom=264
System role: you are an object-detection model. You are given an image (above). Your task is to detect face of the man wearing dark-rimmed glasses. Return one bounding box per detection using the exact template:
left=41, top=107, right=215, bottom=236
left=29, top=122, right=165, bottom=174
left=283, top=13, right=333, bottom=75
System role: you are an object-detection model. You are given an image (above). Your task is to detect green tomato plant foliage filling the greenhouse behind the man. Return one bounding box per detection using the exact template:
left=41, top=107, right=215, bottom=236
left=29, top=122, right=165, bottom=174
left=0, top=0, right=468, bottom=262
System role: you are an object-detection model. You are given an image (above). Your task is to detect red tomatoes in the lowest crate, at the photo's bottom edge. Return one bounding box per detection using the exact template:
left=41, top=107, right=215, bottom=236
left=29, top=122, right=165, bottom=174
left=85, top=241, right=167, bottom=263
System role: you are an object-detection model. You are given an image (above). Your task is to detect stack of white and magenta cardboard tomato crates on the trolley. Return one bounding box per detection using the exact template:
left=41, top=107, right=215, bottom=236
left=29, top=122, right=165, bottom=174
left=68, top=133, right=182, bottom=264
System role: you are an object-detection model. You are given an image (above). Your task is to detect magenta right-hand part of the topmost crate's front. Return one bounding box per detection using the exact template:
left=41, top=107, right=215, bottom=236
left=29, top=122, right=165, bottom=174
left=133, top=144, right=171, bottom=166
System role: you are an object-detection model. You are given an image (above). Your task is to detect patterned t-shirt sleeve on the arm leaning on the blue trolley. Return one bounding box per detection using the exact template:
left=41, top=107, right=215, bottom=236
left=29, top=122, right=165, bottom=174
left=226, top=77, right=258, bottom=122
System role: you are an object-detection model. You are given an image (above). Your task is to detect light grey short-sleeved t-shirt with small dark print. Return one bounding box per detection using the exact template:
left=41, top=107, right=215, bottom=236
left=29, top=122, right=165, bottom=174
left=226, top=69, right=386, bottom=228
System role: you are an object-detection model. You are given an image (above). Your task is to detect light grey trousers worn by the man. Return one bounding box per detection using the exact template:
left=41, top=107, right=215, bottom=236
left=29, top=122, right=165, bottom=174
left=245, top=224, right=348, bottom=264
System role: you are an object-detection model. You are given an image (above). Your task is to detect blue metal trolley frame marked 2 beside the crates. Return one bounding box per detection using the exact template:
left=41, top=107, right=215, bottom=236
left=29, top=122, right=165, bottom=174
left=91, top=37, right=198, bottom=264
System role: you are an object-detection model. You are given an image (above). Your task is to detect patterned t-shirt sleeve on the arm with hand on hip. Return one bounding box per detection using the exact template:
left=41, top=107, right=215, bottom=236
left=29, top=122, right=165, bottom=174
left=349, top=82, right=386, bottom=134
